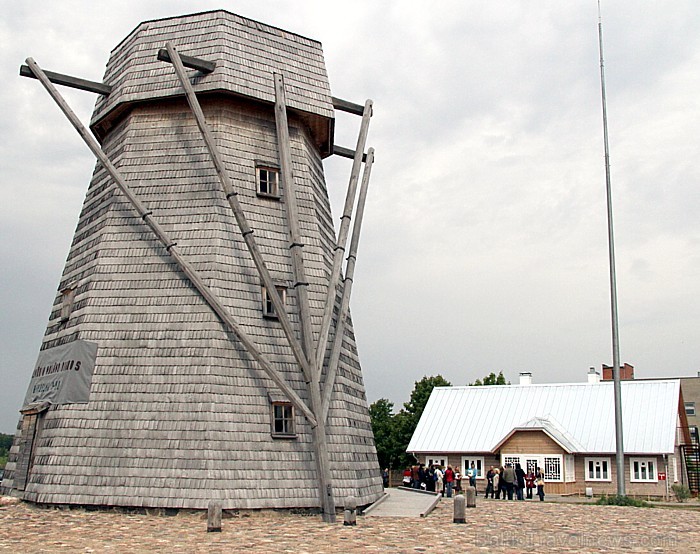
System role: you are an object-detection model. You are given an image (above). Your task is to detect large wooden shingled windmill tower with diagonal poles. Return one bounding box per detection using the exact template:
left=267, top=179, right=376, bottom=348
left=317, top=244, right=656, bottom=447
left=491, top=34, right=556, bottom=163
left=2, top=11, right=382, bottom=521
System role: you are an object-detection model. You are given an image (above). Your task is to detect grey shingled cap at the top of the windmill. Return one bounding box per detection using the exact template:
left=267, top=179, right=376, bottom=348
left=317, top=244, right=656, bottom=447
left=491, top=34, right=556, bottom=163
left=92, top=10, right=334, bottom=151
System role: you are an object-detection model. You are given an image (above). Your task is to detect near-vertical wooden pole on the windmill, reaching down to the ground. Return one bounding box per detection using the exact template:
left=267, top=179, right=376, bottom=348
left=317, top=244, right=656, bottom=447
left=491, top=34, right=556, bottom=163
left=274, top=73, right=335, bottom=522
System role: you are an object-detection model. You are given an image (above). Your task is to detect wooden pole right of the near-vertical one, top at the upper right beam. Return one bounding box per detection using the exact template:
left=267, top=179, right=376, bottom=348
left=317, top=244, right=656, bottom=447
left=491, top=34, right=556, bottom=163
left=315, top=100, right=372, bottom=375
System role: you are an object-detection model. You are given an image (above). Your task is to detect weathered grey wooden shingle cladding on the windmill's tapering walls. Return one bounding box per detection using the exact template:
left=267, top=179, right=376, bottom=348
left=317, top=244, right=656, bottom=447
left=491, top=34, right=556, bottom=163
left=3, top=12, right=382, bottom=508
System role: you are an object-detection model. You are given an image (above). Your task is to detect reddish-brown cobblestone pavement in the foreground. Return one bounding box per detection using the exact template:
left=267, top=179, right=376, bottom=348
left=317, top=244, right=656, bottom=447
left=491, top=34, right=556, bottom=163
left=0, top=499, right=700, bottom=554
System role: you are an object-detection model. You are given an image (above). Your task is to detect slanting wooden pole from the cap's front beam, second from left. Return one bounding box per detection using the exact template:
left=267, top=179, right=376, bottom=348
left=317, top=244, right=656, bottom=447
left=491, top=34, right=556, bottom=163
left=165, top=42, right=310, bottom=375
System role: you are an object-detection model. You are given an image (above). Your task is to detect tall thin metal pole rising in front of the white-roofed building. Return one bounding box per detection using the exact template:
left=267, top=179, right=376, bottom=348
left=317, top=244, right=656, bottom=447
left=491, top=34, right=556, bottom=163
left=598, top=0, right=625, bottom=496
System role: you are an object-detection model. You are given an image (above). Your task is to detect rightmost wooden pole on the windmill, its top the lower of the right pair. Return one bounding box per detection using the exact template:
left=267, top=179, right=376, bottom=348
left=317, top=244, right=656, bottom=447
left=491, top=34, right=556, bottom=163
left=322, top=148, right=374, bottom=421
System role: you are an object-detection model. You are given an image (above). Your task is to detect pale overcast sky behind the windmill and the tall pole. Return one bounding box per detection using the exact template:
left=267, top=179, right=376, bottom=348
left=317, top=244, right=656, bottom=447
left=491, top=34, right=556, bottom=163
left=0, top=0, right=700, bottom=432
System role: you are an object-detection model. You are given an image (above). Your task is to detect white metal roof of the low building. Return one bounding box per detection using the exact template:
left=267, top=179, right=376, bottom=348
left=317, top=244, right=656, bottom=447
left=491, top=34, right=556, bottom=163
left=407, top=379, right=680, bottom=454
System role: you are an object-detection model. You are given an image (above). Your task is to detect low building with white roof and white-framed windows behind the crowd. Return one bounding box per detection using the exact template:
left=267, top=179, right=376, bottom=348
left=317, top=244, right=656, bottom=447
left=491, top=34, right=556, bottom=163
left=407, top=370, right=689, bottom=496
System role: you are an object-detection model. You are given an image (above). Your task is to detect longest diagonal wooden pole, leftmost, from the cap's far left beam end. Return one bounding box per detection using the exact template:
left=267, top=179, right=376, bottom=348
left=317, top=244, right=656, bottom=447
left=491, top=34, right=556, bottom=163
left=21, top=58, right=317, bottom=427
